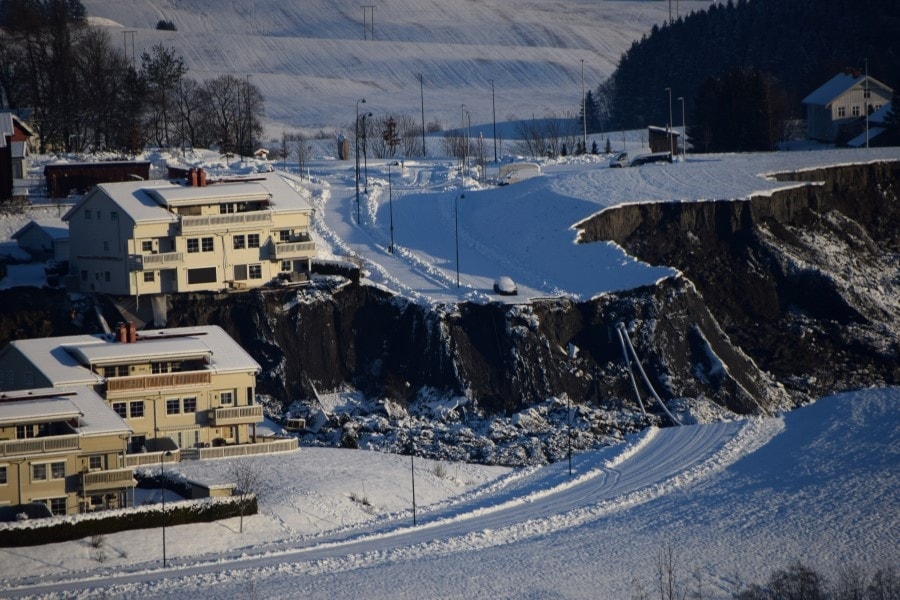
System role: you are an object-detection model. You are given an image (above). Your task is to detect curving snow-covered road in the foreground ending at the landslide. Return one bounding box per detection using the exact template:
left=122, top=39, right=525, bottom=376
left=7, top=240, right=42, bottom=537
left=9, top=419, right=783, bottom=598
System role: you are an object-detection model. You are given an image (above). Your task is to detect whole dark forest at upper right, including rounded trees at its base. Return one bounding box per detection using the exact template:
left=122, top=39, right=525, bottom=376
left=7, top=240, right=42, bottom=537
left=579, top=0, right=900, bottom=152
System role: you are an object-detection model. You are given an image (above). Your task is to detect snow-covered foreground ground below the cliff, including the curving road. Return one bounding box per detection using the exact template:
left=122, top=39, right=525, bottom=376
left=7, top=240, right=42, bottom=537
left=0, top=388, right=900, bottom=600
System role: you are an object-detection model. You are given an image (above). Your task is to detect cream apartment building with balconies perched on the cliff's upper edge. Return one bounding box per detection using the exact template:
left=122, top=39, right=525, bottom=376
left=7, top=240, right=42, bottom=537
left=63, top=170, right=315, bottom=296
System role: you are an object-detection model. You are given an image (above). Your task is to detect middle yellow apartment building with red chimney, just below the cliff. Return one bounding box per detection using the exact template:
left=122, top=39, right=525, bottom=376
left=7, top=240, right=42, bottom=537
left=0, top=324, right=263, bottom=466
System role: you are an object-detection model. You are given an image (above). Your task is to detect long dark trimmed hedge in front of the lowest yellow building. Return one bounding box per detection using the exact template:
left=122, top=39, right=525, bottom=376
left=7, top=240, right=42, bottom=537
left=0, top=498, right=259, bottom=548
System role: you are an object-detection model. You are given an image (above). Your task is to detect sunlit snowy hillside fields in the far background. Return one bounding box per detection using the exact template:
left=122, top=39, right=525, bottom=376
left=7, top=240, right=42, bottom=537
left=83, top=0, right=709, bottom=136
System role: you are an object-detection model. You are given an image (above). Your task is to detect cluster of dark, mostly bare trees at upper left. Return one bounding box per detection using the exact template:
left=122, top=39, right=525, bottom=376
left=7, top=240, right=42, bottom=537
left=0, top=0, right=264, bottom=155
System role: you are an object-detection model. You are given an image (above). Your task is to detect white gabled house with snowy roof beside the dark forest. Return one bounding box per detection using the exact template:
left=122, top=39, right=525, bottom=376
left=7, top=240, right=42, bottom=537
left=803, top=71, right=894, bottom=143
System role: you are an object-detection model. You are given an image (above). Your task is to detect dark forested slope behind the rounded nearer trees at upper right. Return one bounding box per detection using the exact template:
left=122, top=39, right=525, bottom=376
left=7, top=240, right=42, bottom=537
left=600, top=0, right=900, bottom=128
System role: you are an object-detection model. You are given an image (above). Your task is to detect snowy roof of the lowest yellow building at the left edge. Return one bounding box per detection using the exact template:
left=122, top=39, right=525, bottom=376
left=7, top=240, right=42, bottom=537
left=0, top=387, right=132, bottom=436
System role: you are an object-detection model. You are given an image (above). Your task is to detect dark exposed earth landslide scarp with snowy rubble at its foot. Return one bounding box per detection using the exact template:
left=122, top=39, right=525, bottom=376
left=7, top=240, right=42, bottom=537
left=0, top=163, right=900, bottom=464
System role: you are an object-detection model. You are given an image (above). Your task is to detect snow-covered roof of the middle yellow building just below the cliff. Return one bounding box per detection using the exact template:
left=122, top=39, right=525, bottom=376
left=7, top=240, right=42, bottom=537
left=10, top=325, right=260, bottom=386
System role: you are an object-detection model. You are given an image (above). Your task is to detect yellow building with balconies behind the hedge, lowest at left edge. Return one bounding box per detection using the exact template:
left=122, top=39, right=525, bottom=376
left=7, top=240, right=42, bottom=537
left=0, top=386, right=137, bottom=517
